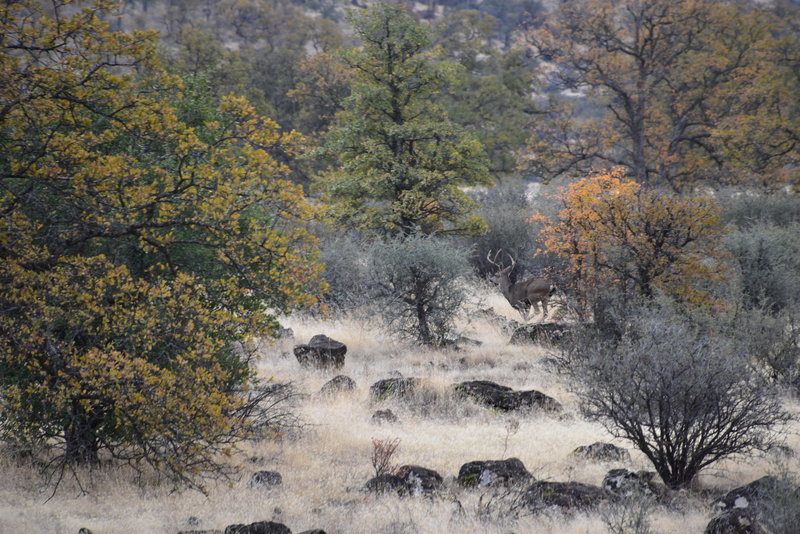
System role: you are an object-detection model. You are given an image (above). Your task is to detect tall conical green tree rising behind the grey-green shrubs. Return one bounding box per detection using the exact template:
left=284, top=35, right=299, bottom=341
left=317, top=4, right=488, bottom=235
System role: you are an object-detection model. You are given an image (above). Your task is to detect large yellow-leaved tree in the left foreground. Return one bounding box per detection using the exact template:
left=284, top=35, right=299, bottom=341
left=0, top=0, right=319, bottom=494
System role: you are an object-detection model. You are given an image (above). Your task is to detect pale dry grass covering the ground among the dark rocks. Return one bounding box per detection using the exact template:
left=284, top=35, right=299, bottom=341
left=0, top=297, right=800, bottom=534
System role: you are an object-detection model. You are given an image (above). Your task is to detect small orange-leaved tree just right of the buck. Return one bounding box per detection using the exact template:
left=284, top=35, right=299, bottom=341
left=537, top=171, right=728, bottom=314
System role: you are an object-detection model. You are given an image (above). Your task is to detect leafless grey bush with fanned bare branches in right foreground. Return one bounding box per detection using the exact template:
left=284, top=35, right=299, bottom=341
left=567, top=304, right=788, bottom=488
